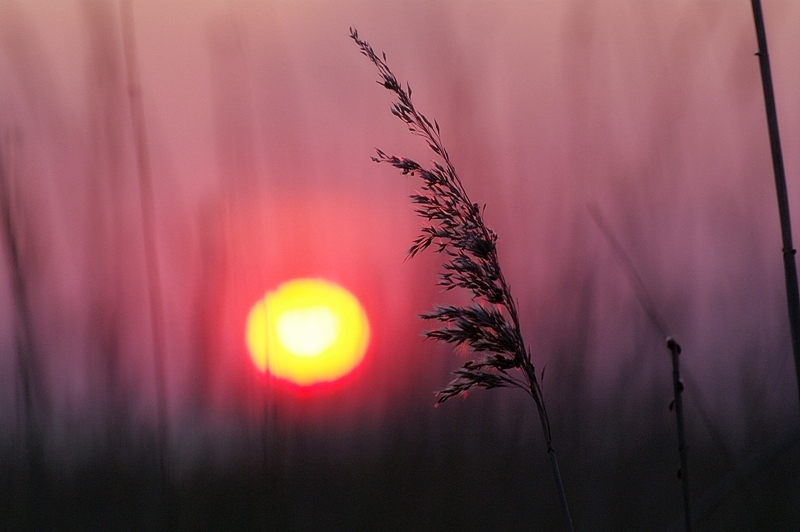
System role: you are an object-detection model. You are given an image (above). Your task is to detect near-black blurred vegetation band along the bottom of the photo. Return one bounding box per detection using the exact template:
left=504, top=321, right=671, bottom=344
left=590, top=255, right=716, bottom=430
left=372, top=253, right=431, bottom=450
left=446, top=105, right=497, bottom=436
left=0, top=379, right=800, bottom=531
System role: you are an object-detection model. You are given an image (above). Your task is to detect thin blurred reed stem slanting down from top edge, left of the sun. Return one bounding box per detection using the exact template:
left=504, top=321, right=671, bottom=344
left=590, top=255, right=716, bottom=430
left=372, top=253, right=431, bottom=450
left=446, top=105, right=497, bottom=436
left=120, top=0, right=169, bottom=516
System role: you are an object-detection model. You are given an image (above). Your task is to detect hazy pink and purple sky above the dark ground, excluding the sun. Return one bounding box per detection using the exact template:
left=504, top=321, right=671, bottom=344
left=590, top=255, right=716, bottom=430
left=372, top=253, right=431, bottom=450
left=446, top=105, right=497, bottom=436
left=0, top=0, right=800, bottom=528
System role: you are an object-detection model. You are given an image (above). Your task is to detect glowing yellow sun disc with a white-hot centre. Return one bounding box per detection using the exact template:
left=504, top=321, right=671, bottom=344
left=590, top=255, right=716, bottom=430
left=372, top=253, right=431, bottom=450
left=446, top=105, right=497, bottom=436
left=245, top=279, right=370, bottom=386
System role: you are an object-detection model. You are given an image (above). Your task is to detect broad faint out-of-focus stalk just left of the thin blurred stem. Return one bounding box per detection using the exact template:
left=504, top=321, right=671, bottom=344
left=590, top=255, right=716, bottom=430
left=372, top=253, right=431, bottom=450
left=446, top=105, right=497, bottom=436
left=79, top=0, right=131, bottom=462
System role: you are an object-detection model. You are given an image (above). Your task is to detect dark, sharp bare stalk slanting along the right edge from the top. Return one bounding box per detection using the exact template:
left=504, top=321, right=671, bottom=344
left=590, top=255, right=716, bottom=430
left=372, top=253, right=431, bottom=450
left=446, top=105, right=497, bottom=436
left=751, top=0, right=800, bottom=414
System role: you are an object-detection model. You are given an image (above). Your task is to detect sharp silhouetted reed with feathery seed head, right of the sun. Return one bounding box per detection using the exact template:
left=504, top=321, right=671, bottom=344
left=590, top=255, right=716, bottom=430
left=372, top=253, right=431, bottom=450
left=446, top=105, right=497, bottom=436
left=350, top=28, right=573, bottom=531
